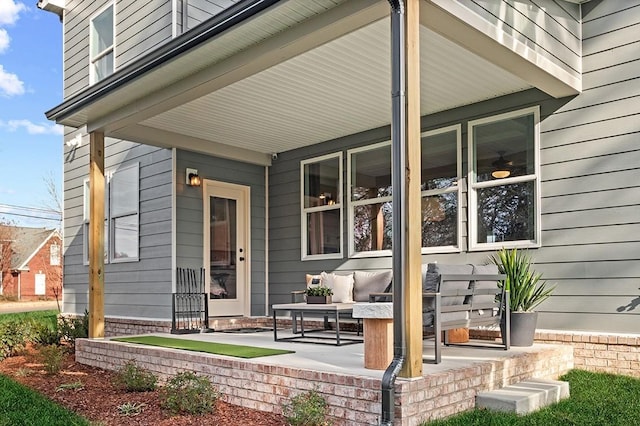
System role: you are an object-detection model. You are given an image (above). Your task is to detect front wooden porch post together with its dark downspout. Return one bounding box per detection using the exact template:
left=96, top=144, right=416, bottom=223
left=383, top=0, right=422, bottom=378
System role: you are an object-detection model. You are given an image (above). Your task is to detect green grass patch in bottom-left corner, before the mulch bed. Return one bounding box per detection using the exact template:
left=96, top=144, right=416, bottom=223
left=0, top=374, right=90, bottom=426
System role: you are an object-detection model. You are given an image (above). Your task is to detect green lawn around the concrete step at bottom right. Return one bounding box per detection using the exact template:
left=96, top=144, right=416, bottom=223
left=423, top=370, right=640, bottom=426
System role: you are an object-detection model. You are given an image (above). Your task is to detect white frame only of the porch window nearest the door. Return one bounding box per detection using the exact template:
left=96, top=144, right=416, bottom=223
left=300, top=152, right=344, bottom=260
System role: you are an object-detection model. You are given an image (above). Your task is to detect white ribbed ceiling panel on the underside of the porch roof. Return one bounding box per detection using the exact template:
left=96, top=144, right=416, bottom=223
left=142, top=18, right=531, bottom=153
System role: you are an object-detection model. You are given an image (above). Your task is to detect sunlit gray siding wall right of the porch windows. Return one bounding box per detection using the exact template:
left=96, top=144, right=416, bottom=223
left=536, top=1, right=640, bottom=332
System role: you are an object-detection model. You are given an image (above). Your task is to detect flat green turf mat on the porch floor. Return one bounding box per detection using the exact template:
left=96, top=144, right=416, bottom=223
left=111, top=336, right=294, bottom=358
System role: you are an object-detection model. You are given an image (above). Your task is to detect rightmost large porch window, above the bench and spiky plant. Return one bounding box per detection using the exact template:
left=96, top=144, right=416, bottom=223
left=469, top=107, right=540, bottom=250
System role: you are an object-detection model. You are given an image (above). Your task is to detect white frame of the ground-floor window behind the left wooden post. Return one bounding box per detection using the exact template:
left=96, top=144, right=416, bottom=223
left=82, top=162, right=140, bottom=265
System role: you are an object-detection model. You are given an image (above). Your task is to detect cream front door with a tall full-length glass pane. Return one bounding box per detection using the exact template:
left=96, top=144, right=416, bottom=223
left=203, top=180, right=250, bottom=317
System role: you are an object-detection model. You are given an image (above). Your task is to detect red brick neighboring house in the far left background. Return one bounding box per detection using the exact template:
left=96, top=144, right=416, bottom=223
left=0, top=225, right=62, bottom=300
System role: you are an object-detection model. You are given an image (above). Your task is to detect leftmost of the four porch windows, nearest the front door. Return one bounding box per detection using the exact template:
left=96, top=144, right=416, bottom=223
left=300, top=153, right=342, bottom=260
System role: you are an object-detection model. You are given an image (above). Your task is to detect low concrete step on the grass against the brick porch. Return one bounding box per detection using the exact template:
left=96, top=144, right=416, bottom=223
left=476, top=379, right=569, bottom=414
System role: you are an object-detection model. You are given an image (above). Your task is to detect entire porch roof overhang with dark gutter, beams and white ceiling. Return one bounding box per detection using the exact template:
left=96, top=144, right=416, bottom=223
left=47, top=0, right=580, bottom=165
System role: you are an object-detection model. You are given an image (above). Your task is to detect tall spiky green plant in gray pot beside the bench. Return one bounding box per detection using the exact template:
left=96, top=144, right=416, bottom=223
left=491, top=248, right=555, bottom=346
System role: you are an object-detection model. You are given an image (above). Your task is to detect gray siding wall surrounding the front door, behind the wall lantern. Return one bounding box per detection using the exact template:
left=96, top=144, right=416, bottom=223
left=176, top=150, right=266, bottom=315
